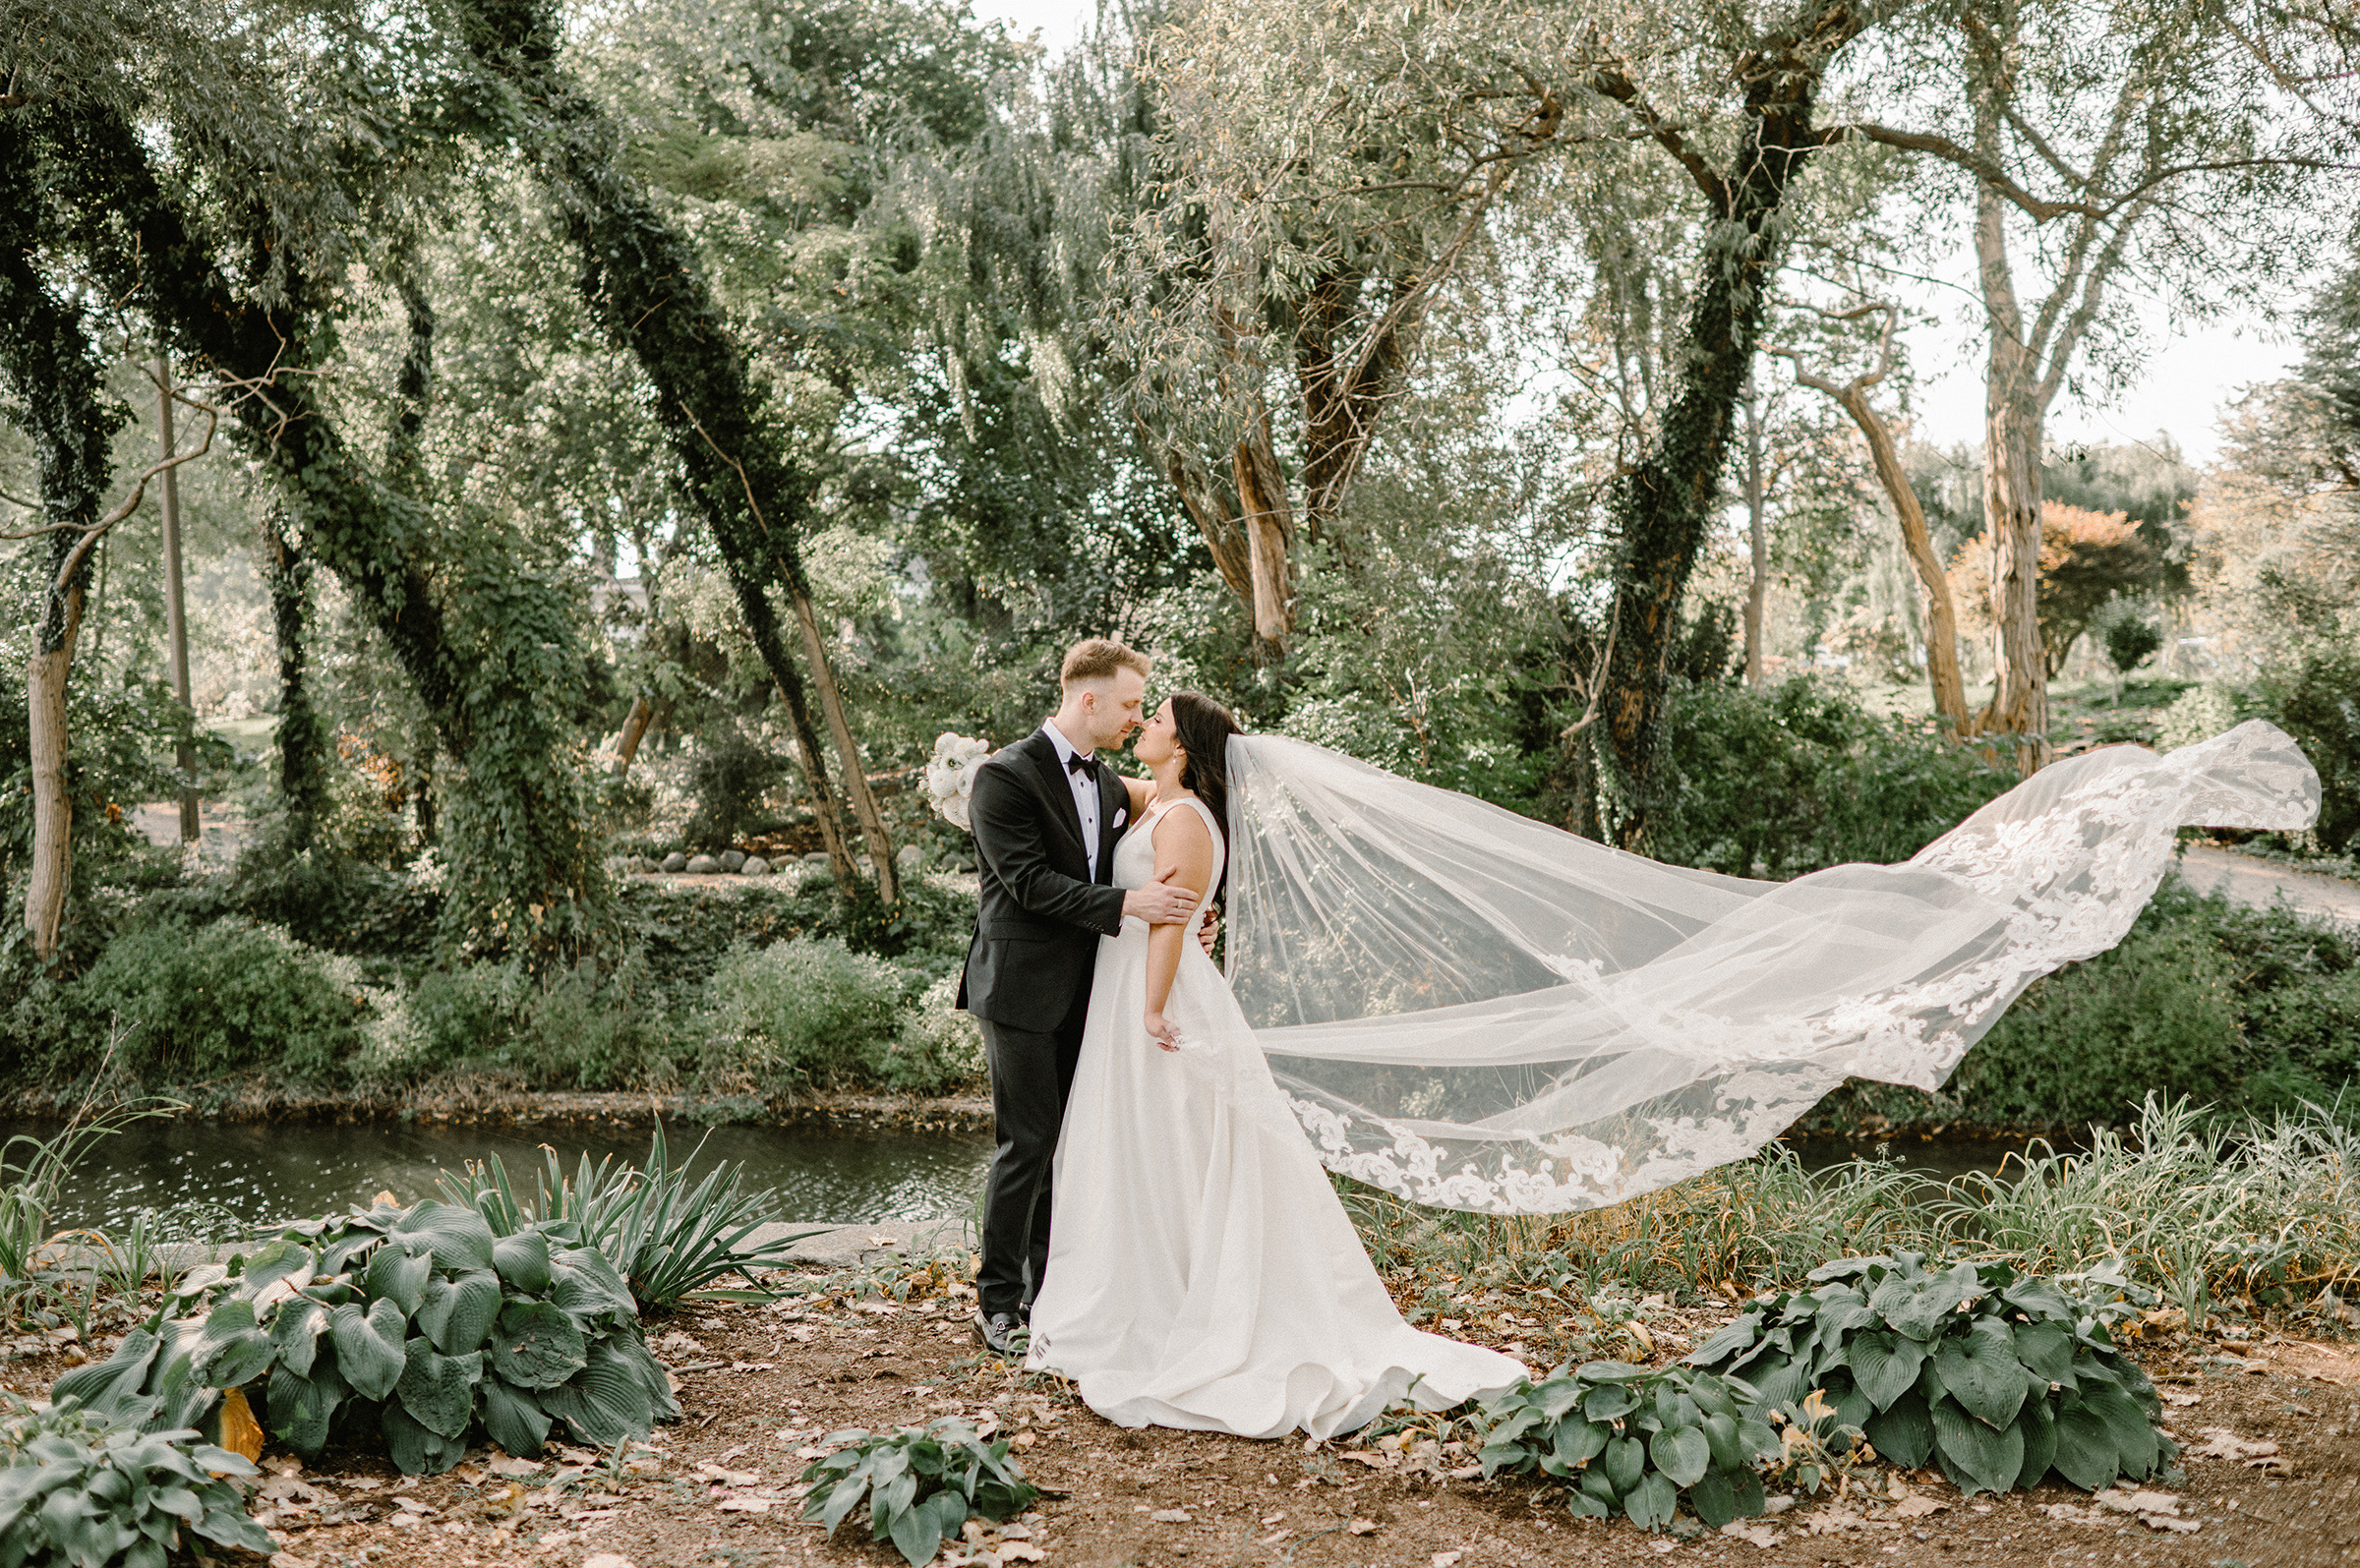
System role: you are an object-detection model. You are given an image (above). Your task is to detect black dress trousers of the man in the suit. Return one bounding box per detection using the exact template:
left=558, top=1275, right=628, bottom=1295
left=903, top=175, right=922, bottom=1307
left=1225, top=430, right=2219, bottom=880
left=974, top=986, right=1091, bottom=1318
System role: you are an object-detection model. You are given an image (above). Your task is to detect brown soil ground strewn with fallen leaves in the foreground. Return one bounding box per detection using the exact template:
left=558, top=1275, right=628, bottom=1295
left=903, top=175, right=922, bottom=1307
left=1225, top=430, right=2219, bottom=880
left=0, top=1276, right=2360, bottom=1568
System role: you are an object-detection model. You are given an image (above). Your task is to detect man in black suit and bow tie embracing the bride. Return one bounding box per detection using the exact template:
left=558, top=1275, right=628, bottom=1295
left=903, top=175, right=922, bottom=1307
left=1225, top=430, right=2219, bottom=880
left=956, top=637, right=1197, bottom=1356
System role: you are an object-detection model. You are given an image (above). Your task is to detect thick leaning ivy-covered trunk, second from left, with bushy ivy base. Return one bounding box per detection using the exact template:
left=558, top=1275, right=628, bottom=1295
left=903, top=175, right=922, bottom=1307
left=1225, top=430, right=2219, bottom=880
left=40, top=106, right=607, bottom=964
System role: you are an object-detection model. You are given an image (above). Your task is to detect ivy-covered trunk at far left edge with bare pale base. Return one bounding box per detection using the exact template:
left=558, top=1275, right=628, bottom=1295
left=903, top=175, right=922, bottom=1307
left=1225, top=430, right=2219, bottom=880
left=0, top=113, right=130, bottom=962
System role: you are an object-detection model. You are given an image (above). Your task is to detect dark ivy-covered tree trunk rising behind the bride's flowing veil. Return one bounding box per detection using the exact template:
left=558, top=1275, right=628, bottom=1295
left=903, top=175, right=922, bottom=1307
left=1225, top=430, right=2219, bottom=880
left=1595, top=39, right=1859, bottom=848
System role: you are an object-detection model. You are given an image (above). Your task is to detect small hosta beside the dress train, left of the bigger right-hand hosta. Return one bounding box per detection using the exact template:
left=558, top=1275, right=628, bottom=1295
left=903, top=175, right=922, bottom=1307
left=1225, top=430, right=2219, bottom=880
left=1475, top=1361, right=1782, bottom=1531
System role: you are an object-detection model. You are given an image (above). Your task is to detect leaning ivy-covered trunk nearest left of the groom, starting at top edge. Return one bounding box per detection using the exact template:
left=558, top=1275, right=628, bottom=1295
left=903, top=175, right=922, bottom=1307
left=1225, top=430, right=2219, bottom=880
left=460, top=0, right=899, bottom=900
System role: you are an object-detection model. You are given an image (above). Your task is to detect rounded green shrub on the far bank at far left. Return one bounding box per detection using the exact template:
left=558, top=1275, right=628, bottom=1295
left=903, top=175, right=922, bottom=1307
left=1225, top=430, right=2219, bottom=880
left=81, top=919, right=364, bottom=1082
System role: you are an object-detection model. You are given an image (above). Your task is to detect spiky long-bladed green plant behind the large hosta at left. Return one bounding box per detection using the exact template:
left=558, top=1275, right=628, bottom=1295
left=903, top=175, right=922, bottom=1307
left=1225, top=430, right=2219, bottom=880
left=437, top=1125, right=819, bottom=1313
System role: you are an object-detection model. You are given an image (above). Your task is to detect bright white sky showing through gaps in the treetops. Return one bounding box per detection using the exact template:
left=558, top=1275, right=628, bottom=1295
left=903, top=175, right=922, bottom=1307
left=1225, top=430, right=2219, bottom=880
left=974, top=0, right=2301, bottom=467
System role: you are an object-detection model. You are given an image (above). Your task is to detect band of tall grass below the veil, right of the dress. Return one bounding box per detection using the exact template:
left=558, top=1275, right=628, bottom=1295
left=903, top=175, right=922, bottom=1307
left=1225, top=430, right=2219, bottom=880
left=1345, top=1094, right=2360, bottom=1325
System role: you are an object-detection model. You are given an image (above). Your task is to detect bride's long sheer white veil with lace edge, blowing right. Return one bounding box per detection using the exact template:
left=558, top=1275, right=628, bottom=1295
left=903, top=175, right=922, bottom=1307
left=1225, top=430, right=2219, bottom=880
left=1229, top=722, right=2320, bottom=1214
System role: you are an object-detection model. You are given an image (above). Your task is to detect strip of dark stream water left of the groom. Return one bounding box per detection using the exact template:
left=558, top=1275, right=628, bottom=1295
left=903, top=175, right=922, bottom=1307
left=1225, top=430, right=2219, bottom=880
left=0, top=1118, right=991, bottom=1229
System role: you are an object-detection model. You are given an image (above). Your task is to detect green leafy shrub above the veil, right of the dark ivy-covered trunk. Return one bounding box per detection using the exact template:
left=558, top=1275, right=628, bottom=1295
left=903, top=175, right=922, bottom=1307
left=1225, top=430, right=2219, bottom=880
left=1647, top=676, right=2016, bottom=880
